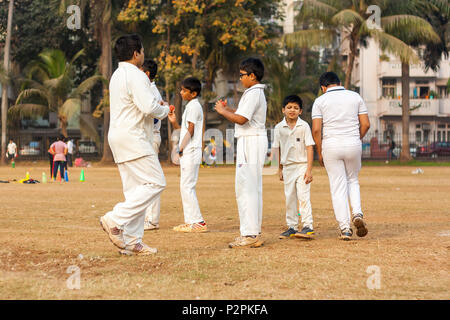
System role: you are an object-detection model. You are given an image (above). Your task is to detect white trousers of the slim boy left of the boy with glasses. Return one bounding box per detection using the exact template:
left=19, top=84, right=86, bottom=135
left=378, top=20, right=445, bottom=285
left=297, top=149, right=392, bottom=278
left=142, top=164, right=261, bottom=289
left=180, top=148, right=204, bottom=224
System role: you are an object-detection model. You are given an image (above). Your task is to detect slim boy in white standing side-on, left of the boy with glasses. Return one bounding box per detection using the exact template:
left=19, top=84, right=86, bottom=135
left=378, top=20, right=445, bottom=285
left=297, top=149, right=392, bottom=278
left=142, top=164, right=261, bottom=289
left=169, top=77, right=208, bottom=232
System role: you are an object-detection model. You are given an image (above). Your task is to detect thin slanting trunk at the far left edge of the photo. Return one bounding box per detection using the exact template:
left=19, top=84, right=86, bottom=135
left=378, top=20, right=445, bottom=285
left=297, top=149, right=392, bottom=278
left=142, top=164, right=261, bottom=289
left=0, top=0, right=14, bottom=164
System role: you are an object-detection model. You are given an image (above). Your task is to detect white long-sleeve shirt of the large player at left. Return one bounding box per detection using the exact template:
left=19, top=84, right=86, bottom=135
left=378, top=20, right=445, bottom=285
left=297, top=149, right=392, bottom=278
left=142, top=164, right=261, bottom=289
left=108, top=62, right=169, bottom=163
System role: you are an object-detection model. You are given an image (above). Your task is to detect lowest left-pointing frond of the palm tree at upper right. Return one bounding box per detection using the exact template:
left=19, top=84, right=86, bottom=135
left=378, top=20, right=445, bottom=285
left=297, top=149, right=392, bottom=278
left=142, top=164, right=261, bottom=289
left=282, top=29, right=335, bottom=48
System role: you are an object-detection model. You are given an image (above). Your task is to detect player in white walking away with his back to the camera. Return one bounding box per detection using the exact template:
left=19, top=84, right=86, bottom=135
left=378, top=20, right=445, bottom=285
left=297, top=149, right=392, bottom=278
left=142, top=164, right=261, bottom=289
left=311, top=72, right=370, bottom=240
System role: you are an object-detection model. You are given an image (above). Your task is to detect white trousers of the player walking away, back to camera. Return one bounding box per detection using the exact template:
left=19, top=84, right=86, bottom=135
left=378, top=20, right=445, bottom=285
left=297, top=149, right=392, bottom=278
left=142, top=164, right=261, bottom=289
left=322, top=145, right=362, bottom=230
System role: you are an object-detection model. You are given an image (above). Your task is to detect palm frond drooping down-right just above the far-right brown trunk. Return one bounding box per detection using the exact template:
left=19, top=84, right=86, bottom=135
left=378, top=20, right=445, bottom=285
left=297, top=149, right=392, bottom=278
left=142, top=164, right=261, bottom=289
left=371, top=30, right=420, bottom=64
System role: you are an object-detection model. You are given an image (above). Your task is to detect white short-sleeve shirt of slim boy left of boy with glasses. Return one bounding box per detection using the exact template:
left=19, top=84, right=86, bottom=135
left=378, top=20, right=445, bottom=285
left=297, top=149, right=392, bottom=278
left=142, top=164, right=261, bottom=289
left=179, top=98, right=203, bottom=152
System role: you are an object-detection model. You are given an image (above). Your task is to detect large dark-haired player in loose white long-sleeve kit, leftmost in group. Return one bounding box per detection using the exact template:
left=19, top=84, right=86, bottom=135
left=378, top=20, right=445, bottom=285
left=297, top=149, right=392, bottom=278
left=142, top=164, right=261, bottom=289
left=100, top=35, right=169, bottom=255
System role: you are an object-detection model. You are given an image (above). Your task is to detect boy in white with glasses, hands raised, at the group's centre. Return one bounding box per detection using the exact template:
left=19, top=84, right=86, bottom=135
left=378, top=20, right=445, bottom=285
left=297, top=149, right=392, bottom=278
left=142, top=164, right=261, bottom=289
left=216, top=58, right=268, bottom=248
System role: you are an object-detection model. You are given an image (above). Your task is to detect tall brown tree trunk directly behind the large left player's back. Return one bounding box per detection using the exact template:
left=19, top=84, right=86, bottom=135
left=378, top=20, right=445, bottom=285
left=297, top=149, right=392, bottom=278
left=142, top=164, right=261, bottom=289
left=99, top=9, right=114, bottom=163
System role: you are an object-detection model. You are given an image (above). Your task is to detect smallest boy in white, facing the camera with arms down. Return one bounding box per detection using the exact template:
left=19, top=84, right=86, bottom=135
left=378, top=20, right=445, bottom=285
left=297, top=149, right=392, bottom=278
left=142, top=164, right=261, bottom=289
left=272, top=95, right=315, bottom=239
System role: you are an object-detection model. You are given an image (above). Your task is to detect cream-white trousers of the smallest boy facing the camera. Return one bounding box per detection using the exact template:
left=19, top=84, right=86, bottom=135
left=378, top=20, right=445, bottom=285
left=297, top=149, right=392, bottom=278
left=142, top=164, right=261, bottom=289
left=283, top=163, right=313, bottom=230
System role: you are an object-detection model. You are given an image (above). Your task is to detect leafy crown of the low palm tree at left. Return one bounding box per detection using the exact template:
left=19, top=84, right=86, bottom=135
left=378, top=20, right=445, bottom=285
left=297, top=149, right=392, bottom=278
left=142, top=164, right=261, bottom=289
left=9, top=50, right=105, bottom=137
